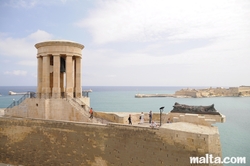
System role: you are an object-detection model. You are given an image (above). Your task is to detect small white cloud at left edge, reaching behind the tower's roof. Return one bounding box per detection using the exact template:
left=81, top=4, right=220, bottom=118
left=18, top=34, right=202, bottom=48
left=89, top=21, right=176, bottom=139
left=0, top=30, right=53, bottom=58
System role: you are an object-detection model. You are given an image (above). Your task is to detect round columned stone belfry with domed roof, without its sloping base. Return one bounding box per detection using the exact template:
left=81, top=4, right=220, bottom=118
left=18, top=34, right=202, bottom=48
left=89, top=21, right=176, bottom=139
left=35, top=40, right=84, bottom=99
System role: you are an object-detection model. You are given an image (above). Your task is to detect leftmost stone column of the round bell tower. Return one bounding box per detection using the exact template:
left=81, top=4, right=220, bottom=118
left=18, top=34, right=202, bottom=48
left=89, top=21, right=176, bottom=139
left=36, top=55, right=43, bottom=98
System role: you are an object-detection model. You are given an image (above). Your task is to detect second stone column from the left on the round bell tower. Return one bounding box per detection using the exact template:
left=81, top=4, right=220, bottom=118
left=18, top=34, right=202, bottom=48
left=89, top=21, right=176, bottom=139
left=41, top=55, right=51, bottom=99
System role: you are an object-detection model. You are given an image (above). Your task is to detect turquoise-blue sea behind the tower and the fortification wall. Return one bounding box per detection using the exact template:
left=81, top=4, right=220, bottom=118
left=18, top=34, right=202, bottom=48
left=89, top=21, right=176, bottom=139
left=0, top=86, right=250, bottom=166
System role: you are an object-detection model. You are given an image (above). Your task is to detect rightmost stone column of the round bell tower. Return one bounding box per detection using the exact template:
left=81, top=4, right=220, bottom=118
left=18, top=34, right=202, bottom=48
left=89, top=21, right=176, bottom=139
left=75, top=57, right=82, bottom=98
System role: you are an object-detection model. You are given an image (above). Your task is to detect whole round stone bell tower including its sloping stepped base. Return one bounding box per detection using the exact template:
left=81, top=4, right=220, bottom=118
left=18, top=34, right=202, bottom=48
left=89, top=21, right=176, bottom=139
left=5, top=40, right=93, bottom=122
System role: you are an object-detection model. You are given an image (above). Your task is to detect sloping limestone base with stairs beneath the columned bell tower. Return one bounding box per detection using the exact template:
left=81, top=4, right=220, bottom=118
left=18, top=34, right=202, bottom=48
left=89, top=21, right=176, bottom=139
left=5, top=98, right=90, bottom=122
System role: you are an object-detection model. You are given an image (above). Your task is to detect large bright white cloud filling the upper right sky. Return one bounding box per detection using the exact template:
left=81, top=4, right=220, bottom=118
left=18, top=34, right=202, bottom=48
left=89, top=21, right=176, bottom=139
left=77, top=0, right=250, bottom=43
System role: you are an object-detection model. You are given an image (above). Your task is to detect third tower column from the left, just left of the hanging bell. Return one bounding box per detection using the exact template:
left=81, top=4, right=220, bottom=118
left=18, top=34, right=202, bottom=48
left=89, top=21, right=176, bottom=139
left=52, top=54, right=61, bottom=98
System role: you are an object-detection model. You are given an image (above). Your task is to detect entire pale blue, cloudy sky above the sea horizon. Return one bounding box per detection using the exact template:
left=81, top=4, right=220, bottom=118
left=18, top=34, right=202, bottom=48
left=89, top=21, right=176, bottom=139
left=0, top=0, right=250, bottom=87
